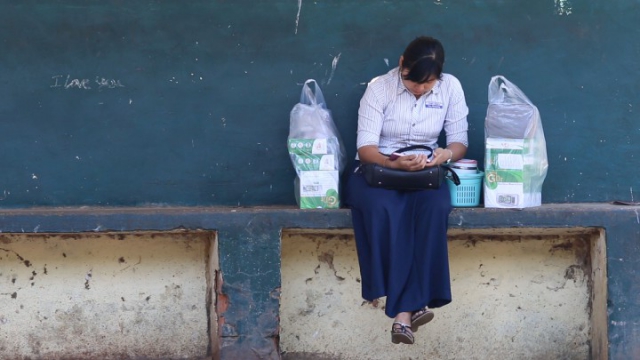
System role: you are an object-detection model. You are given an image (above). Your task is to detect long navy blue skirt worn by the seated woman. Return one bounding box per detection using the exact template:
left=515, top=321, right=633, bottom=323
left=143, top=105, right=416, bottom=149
left=344, top=161, right=452, bottom=318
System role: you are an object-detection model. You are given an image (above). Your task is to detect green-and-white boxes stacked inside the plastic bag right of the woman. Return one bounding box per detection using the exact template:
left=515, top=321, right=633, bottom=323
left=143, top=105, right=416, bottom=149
left=484, top=138, right=542, bottom=208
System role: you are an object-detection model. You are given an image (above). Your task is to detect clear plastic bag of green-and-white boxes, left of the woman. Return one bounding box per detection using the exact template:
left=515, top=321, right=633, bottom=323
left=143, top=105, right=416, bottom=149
left=287, top=79, right=346, bottom=209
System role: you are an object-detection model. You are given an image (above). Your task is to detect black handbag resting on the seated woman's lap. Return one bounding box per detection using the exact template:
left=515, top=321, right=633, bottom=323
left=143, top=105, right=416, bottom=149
left=358, top=145, right=460, bottom=190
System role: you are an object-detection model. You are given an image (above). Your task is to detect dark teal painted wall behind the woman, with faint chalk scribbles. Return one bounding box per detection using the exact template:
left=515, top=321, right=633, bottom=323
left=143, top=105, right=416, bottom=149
left=0, top=0, right=640, bottom=207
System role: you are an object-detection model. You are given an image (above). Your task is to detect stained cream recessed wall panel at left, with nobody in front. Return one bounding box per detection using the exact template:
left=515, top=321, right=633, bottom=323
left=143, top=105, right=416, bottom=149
left=0, top=232, right=217, bottom=359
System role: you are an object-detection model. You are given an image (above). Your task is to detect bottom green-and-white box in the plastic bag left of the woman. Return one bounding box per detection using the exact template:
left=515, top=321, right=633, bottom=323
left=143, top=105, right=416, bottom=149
left=296, top=171, right=340, bottom=209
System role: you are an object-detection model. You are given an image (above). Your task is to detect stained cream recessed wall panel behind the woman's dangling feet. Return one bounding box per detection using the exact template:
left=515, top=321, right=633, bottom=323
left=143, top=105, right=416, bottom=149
left=280, top=229, right=606, bottom=360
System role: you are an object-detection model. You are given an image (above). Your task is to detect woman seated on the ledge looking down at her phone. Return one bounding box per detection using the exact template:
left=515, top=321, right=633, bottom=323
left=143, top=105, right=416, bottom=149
left=345, top=36, right=469, bottom=344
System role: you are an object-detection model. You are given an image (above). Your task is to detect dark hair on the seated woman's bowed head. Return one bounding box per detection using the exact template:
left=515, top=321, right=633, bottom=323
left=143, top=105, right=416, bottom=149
left=400, top=36, right=444, bottom=84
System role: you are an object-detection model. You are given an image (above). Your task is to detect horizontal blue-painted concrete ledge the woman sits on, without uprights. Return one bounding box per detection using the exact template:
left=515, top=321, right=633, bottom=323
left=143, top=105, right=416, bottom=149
left=0, top=203, right=640, bottom=233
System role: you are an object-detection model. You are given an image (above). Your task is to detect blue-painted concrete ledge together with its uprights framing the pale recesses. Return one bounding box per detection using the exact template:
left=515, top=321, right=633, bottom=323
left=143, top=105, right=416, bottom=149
left=0, top=203, right=640, bottom=359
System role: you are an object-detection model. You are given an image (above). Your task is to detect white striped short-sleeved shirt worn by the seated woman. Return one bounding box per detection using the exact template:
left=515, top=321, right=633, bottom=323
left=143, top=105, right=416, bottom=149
left=356, top=68, right=469, bottom=158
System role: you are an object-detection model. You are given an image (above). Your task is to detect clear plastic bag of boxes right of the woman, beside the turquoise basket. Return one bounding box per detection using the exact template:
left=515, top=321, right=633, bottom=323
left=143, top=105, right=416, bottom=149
left=484, top=76, right=549, bottom=208
